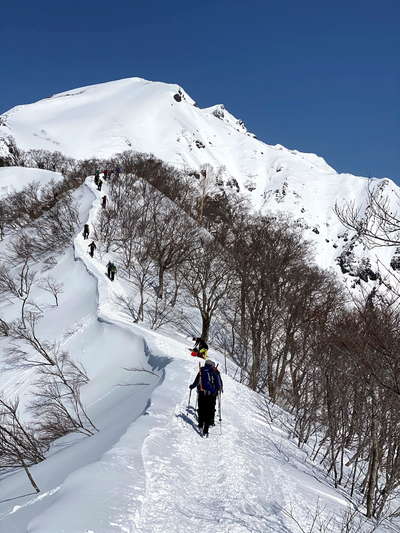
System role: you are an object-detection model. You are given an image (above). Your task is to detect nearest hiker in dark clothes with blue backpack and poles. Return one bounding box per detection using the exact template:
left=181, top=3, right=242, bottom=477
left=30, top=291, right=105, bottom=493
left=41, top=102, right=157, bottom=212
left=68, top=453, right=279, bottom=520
left=189, top=359, right=223, bottom=437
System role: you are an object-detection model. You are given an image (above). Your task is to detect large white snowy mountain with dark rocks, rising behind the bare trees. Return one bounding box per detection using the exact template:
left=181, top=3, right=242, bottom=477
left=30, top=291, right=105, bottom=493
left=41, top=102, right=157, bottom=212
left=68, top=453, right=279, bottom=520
left=0, top=78, right=399, bottom=282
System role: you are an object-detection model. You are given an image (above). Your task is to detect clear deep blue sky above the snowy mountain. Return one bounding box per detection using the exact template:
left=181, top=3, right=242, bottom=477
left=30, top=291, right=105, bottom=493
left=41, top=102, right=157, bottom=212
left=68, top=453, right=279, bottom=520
left=0, top=0, right=400, bottom=181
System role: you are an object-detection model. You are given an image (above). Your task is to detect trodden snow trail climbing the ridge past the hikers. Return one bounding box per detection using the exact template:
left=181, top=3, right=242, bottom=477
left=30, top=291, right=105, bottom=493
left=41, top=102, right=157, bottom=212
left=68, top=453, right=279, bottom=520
left=60, top=179, right=354, bottom=533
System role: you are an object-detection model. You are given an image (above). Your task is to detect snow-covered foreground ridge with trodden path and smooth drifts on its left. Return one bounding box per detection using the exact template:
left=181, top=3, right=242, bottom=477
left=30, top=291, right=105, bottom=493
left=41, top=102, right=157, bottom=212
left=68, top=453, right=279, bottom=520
left=0, top=179, right=379, bottom=533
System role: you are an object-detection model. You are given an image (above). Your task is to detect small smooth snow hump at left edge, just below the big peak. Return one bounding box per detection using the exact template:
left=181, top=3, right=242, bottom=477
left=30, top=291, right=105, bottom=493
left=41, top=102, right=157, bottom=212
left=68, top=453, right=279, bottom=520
left=0, top=167, right=63, bottom=199
